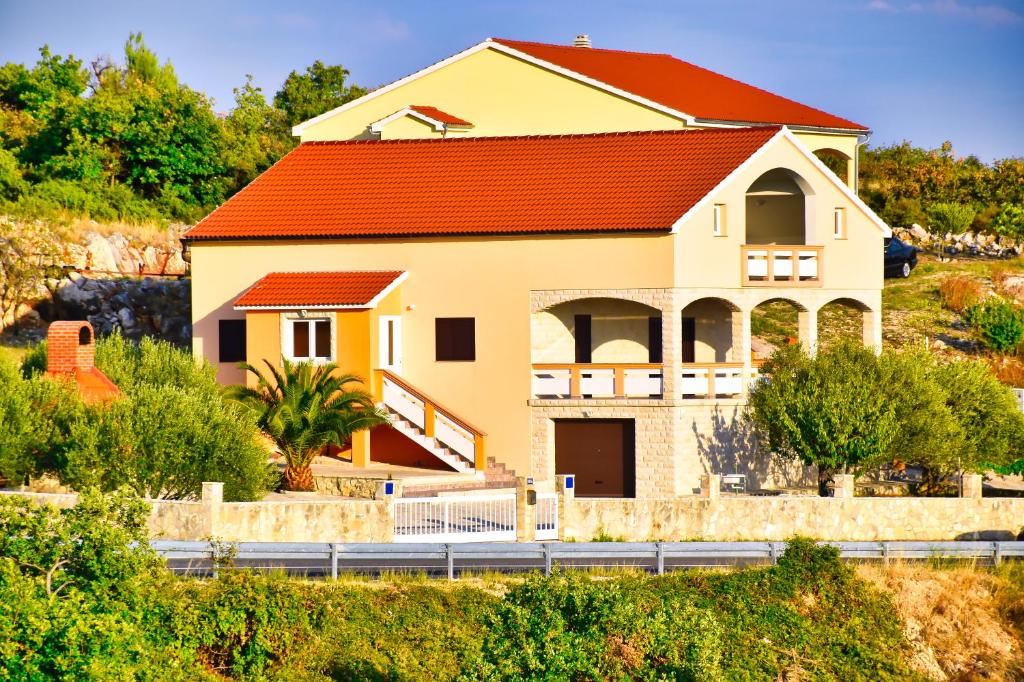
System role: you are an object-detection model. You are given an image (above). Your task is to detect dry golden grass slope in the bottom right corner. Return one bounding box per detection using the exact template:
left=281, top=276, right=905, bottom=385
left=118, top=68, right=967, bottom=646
left=857, top=563, right=1024, bottom=680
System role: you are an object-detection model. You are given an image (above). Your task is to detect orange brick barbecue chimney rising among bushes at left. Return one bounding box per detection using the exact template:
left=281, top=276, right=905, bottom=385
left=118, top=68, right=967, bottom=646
left=46, top=321, right=121, bottom=402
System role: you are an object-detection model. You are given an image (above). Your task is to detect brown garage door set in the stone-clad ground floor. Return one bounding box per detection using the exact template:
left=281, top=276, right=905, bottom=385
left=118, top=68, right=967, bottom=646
left=555, top=419, right=636, bottom=498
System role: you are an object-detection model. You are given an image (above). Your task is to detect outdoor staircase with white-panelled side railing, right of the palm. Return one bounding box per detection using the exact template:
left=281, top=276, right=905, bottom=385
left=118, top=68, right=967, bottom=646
left=375, top=370, right=486, bottom=478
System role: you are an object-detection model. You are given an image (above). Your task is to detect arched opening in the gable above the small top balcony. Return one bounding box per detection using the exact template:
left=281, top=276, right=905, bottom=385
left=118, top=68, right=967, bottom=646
left=745, top=168, right=814, bottom=246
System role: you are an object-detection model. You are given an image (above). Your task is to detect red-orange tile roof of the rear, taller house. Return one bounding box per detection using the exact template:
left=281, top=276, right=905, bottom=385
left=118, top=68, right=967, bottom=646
left=492, top=38, right=867, bottom=131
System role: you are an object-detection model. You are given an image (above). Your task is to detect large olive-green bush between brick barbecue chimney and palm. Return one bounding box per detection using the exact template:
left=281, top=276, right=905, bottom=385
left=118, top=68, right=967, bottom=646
left=22, top=335, right=278, bottom=501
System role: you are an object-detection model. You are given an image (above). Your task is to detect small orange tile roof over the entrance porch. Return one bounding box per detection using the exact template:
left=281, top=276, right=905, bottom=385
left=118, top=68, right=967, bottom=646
left=234, top=270, right=403, bottom=308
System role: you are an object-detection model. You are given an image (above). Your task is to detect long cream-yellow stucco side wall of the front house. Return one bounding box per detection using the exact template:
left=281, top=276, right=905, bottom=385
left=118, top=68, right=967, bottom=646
left=191, top=235, right=672, bottom=471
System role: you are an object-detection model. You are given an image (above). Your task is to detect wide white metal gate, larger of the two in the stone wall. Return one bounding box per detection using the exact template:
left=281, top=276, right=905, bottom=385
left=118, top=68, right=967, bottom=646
left=394, top=493, right=516, bottom=543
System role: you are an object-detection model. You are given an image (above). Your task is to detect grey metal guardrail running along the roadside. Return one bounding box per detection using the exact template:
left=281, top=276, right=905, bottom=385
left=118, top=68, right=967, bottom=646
left=151, top=541, right=1024, bottom=579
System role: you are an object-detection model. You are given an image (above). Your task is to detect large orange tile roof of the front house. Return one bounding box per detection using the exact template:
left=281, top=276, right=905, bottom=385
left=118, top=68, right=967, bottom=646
left=185, top=126, right=779, bottom=241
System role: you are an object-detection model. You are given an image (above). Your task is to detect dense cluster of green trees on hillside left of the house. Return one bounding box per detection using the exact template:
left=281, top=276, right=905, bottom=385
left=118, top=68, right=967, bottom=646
left=0, top=34, right=365, bottom=223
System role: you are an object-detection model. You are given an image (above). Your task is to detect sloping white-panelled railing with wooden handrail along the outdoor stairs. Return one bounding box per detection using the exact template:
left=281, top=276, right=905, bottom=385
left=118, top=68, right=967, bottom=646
left=375, top=370, right=487, bottom=471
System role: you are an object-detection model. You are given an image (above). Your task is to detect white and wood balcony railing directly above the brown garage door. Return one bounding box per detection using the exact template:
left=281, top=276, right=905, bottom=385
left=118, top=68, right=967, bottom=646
left=532, top=363, right=664, bottom=398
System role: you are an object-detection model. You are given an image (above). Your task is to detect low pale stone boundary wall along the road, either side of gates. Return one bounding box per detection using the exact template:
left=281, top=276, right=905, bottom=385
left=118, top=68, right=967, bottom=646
left=4, top=485, right=1024, bottom=543
